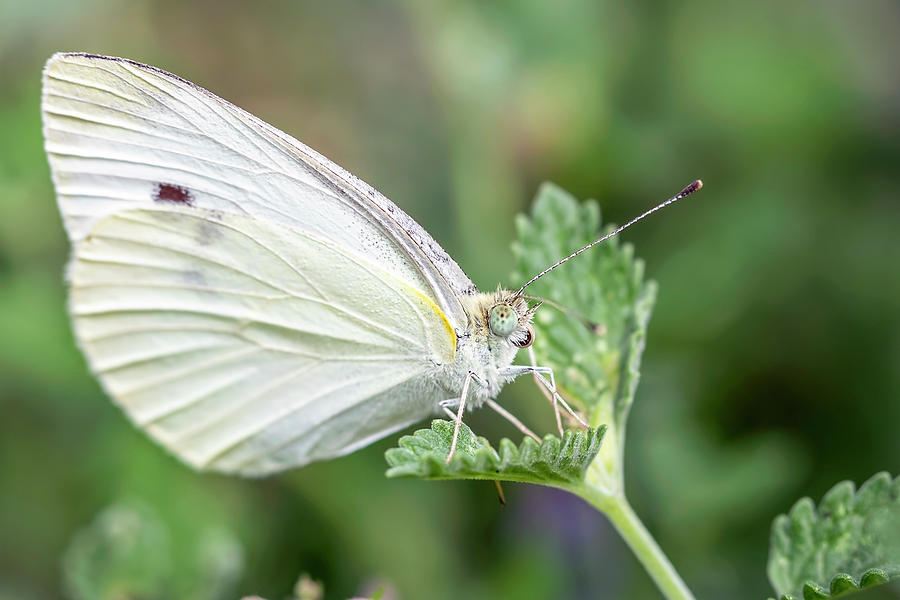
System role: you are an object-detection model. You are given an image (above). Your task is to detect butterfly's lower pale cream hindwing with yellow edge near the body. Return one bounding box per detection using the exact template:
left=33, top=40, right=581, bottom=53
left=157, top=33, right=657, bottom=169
left=69, top=206, right=455, bottom=474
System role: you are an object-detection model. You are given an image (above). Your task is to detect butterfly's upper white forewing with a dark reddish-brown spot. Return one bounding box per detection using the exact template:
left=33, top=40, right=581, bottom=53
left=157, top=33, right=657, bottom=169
left=42, top=54, right=475, bottom=329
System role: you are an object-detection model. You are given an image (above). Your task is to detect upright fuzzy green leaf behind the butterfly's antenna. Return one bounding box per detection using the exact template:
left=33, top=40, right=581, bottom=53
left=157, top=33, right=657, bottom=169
left=513, top=183, right=656, bottom=436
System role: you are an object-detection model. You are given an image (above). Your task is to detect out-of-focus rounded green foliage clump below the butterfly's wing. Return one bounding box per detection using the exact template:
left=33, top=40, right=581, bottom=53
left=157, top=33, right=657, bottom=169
left=63, top=502, right=243, bottom=600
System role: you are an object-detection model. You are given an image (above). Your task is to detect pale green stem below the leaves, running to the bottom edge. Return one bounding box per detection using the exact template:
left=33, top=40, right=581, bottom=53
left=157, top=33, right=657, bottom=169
left=576, top=486, right=694, bottom=600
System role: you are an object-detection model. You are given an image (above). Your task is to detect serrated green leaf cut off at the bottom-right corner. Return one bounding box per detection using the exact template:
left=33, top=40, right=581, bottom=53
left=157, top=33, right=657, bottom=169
left=768, top=473, right=900, bottom=599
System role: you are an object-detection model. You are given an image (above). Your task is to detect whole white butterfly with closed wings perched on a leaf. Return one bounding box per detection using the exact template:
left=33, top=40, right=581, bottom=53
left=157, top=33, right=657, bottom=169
left=42, top=54, right=699, bottom=475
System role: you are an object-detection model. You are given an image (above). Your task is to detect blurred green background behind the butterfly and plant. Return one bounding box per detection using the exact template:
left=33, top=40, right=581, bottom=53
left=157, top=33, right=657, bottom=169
left=0, top=0, right=900, bottom=600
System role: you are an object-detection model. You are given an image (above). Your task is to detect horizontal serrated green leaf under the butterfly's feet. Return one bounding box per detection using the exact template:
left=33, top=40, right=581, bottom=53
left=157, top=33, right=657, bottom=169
left=385, top=419, right=605, bottom=487
